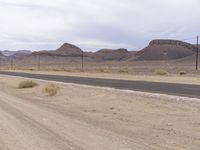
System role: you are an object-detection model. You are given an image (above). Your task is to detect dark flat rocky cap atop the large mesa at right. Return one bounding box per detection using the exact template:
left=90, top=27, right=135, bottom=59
left=149, top=39, right=195, bottom=49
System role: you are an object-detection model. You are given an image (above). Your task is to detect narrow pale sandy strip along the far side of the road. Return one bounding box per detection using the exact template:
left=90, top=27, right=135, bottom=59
left=2, top=70, right=200, bottom=85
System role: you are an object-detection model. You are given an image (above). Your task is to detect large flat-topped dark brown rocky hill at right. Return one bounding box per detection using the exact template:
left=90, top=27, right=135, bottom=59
left=136, top=40, right=195, bottom=60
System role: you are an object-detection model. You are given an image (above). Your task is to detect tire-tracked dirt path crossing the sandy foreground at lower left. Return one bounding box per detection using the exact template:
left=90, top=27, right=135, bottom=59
left=0, top=92, right=146, bottom=150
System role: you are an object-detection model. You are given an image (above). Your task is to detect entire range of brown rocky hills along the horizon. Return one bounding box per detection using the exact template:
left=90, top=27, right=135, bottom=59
left=0, top=39, right=196, bottom=61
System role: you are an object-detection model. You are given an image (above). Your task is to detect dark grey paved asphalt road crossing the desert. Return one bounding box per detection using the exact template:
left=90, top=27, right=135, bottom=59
left=0, top=71, right=200, bottom=98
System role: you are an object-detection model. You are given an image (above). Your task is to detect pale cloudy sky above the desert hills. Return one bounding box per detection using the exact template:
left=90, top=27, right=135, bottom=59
left=0, top=0, right=200, bottom=51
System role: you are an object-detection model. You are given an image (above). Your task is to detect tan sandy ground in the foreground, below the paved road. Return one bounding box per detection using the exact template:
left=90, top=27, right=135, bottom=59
left=0, top=76, right=200, bottom=150
